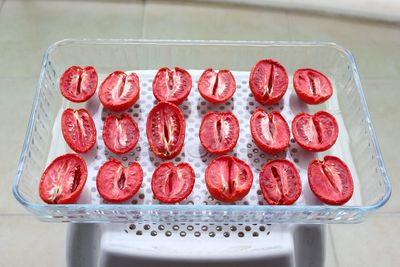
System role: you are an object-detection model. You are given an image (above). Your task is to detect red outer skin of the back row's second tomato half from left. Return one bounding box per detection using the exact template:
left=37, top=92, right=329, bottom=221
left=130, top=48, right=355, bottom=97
left=99, top=70, right=140, bottom=112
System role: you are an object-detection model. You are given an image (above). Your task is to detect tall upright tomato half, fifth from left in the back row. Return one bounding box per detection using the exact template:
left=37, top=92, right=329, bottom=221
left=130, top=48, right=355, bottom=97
left=249, top=59, right=289, bottom=105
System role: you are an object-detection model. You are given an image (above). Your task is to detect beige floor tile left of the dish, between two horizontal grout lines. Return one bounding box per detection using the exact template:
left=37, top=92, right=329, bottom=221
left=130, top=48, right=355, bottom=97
left=0, top=78, right=36, bottom=214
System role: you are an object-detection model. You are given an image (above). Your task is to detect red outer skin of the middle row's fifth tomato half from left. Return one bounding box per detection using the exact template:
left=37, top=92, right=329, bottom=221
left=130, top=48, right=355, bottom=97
left=250, top=108, right=290, bottom=154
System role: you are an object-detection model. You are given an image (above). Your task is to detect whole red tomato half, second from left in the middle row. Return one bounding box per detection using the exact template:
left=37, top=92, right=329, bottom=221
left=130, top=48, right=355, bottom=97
left=103, top=113, right=139, bottom=154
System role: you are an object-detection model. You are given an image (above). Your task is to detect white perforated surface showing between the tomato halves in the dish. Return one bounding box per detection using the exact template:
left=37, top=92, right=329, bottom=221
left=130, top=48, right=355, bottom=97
left=48, top=70, right=359, bottom=209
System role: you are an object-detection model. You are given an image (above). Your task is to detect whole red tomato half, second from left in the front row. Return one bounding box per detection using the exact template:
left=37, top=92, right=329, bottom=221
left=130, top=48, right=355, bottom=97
left=96, top=159, right=143, bottom=203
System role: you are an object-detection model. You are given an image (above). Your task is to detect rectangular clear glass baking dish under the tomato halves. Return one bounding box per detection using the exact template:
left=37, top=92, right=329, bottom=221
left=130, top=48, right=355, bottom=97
left=13, top=40, right=390, bottom=223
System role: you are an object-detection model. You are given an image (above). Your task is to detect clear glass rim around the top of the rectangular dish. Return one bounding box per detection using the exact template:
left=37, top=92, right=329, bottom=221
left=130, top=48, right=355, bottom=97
left=12, top=38, right=392, bottom=222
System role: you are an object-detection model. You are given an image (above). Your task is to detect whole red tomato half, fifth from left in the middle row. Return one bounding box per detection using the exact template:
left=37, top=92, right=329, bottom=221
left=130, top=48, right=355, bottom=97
left=250, top=108, right=290, bottom=154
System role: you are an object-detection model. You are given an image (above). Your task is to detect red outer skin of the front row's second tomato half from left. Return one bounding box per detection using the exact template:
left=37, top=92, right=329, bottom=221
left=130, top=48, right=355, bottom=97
left=96, top=158, right=143, bottom=203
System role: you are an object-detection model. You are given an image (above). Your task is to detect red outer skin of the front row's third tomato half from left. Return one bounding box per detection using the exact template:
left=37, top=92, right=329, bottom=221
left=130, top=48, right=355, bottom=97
left=151, top=162, right=196, bottom=204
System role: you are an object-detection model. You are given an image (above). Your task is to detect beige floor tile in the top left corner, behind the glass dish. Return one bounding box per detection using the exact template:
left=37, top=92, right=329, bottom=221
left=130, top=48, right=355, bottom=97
left=0, top=1, right=143, bottom=77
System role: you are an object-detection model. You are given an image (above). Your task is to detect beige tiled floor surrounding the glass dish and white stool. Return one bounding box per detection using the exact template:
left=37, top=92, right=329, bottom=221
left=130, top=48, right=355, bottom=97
left=0, top=0, right=400, bottom=267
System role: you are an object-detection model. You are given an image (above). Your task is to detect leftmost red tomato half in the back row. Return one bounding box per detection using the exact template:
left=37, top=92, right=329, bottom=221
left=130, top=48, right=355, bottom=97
left=60, top=66, right=98, bottom=103
